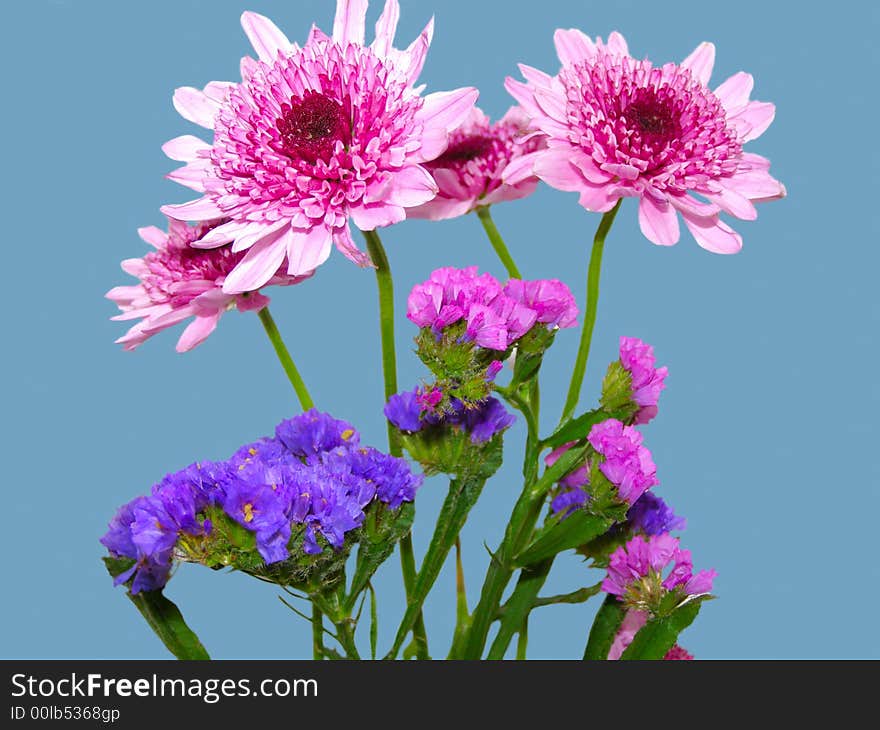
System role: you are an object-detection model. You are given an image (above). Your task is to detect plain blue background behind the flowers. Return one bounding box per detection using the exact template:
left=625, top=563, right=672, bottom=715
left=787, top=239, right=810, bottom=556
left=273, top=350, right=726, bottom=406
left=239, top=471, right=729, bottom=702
left=0, top=0, right=880, bottom=658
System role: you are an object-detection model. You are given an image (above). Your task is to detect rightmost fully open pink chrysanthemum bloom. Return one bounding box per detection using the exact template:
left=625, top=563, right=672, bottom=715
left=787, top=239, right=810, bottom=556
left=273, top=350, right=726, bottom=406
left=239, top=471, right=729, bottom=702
left=505, top=30, right=785, bottom=253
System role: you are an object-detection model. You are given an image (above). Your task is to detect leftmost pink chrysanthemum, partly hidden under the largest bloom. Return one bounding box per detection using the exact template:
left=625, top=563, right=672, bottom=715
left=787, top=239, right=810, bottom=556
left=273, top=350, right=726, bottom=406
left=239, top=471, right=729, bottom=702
left=106, top=219, right=311, bottom=352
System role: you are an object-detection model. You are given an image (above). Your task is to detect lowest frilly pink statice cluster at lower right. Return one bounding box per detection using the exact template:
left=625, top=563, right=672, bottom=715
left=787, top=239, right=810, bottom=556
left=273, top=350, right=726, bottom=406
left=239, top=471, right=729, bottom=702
left=602, top=534, right=717, bottom=611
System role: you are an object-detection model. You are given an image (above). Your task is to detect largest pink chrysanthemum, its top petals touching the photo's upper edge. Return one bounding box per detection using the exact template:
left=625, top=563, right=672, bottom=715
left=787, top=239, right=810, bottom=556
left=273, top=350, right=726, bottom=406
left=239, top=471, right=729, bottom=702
left=163, top=0, right=477, bottom=293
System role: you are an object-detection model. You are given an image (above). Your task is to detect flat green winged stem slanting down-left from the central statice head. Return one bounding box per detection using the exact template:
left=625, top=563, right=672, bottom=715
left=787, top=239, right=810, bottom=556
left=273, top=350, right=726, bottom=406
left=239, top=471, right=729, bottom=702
left=389, top=477, right=486, bottom=656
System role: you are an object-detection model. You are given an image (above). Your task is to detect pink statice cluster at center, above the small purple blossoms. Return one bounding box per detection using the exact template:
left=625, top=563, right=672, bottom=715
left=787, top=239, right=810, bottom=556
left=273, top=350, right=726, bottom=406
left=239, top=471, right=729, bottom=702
left=407, top=266, right=578, bottom=352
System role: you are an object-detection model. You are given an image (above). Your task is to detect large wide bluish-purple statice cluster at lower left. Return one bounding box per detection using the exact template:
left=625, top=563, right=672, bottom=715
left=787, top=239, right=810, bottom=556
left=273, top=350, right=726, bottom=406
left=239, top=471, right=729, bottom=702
left=101, top=409, right=423, bottom=593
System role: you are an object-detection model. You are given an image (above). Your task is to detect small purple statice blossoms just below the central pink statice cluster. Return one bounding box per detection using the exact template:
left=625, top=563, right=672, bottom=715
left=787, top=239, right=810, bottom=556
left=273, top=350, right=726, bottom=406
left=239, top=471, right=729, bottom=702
left=384, top=388, right=516, bottom=444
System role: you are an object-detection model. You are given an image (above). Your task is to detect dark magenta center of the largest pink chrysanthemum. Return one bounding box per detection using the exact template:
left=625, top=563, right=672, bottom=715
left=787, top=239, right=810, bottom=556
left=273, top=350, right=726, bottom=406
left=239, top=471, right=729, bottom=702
left=275, top=91, right=351, bottom=164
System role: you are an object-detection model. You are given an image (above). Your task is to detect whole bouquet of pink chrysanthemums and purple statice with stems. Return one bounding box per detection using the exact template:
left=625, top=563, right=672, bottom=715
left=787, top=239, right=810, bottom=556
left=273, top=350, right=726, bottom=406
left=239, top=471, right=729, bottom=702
left=101, top=0, right=785, bottom=659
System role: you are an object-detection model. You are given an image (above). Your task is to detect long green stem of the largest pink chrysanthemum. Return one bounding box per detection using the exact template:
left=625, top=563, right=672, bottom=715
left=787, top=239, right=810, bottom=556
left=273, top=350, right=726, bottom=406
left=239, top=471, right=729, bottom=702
left=362, top=231, right=428, bottom=659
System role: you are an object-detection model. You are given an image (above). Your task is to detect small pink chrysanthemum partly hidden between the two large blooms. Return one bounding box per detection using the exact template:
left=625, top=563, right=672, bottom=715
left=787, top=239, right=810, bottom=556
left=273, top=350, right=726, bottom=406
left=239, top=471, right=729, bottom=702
left=407, top=106, right=544, bottom=220
